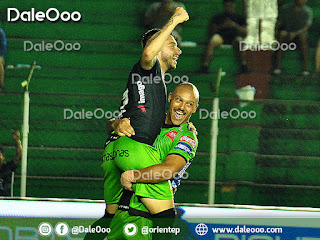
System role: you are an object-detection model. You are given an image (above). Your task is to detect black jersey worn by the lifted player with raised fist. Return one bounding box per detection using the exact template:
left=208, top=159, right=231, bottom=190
left=120, top=60, right=167, bottom=145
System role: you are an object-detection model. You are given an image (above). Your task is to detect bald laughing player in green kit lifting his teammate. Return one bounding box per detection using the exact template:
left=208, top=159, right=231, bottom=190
left=108, top=83, right=199, bottom=240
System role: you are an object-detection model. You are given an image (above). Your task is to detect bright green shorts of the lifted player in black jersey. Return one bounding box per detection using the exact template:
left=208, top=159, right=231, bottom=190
left=101, top=137, right=173, bottom=204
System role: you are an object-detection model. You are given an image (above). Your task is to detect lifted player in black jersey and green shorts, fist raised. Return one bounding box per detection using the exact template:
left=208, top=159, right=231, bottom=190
left=85, top=8, right=189, bottom=239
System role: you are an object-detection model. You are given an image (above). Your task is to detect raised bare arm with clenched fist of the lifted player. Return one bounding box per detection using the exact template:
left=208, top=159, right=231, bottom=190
left=140, top=7, right=189, bottom=70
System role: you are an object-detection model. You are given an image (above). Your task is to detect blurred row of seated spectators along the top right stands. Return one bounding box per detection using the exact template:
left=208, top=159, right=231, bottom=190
left=144, top=0, right=320, bottom=76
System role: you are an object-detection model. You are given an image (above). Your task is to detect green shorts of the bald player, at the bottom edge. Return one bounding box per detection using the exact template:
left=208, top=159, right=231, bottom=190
left=108, top=210, right=152, bottom=240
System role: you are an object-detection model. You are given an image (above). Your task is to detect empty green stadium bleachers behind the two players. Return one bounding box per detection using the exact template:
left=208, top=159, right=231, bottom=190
left=0, top=0, right=320, bottom=207
